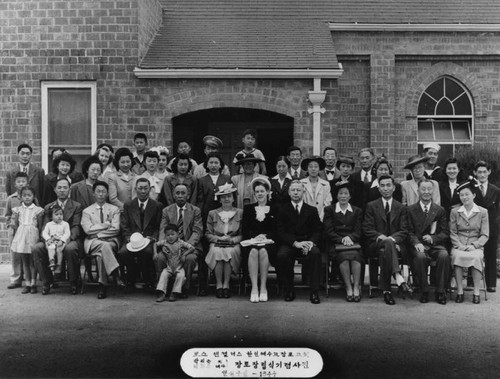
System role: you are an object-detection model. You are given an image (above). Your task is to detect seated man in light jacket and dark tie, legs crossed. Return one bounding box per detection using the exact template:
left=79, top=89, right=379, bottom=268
left=82, top=180, right=125, bottom=299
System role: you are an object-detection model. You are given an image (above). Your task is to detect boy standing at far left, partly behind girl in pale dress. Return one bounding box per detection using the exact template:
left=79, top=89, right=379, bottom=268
left=5, top=171, right=29, bottom=289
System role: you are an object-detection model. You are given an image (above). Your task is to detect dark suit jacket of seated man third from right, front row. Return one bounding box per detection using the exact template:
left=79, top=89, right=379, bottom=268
left=362, top=199, right=408, bottom=245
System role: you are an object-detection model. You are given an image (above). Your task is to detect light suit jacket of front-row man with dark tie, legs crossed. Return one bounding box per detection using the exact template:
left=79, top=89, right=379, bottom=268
left=82, top=203, right=120, bottom=254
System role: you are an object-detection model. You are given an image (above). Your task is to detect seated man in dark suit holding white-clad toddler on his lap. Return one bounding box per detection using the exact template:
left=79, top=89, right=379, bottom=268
left=32, top=178, right=83, bottom=295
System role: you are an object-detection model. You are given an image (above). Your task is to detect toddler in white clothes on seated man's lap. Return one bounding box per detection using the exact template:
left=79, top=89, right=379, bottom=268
left=42, top=205, right=71, bottom=274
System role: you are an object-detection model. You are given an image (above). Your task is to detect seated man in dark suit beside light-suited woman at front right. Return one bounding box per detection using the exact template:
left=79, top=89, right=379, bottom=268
left=408, top=178, right=450, bottom=305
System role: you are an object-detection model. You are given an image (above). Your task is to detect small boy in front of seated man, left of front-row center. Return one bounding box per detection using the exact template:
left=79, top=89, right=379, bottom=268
left=156, top=224, right=195, bottom=303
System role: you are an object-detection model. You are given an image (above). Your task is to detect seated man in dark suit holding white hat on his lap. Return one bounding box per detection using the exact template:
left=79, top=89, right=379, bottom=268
left=118, top=178, right=163, bottom=288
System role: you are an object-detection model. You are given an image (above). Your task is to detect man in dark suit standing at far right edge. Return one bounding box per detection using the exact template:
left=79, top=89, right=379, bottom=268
left=474, top=161, right=500, bottom=292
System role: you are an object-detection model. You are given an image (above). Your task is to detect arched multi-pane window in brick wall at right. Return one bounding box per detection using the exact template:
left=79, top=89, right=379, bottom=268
left=417, top=76, right=474, bottom=163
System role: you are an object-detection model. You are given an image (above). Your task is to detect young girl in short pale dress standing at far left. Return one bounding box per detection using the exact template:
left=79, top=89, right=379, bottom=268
left=11, top=187, right=43, bottom=294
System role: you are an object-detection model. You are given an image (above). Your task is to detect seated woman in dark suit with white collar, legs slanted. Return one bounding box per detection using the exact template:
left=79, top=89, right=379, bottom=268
left=323, top=183, right=364, bottom=303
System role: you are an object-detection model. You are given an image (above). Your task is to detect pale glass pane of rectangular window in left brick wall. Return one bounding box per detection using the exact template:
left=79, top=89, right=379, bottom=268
left=48, top=88, right=91, bottom=147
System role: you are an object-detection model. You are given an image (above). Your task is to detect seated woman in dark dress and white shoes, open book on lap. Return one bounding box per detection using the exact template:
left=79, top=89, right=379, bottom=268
left=242, top=177, right=276, bottom=303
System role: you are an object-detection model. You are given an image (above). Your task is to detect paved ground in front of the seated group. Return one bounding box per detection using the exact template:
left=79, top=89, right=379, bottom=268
left=0, top=266, right=500, bottom=379
